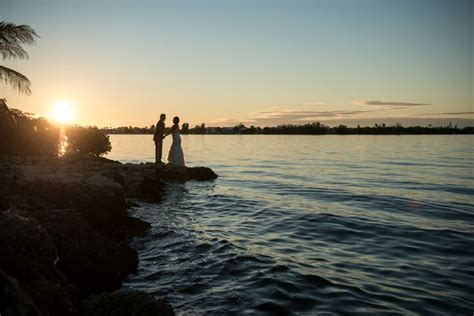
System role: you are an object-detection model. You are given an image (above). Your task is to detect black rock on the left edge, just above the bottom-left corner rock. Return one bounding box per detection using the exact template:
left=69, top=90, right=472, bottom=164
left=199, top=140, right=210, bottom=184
left=0, top=213, right=78, bottom=315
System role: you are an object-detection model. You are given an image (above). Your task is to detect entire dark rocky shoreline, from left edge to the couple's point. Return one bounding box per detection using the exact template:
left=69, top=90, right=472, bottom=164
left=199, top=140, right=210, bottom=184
left=0, top=155, right=217, bottom=316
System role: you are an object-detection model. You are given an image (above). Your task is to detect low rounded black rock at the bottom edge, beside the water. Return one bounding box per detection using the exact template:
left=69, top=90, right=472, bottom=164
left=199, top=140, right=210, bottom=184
left=81, top=291, right=174, bottom=316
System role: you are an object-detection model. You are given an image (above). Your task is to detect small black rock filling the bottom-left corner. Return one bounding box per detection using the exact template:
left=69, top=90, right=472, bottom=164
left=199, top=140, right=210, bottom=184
left=0, top=269, right=40, bottom=316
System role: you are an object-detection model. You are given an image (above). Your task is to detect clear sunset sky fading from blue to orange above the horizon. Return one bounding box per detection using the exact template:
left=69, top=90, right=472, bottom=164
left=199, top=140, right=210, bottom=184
left=0, top=0, right=474, bottom=126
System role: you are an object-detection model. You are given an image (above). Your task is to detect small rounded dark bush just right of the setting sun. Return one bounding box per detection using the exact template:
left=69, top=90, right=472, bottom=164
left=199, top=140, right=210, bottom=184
left=66, top=126, right=112, bottom=156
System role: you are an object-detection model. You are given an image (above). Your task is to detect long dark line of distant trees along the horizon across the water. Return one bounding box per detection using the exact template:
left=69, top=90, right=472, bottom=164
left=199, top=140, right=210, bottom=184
left=103, top=122, right=474, bottom=135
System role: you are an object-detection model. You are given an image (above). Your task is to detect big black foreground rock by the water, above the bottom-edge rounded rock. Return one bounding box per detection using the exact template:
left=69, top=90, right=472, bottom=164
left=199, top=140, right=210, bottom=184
left=31, top=210, right=138, bottom=297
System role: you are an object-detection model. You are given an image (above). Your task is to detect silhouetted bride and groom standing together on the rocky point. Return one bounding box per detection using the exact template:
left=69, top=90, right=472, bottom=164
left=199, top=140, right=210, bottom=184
left=153, top=114, right=184, bottom=166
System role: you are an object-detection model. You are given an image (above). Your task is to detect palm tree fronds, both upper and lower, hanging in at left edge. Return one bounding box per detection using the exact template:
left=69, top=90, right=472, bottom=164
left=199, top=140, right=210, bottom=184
left=0, top=21, right=39, bottom=94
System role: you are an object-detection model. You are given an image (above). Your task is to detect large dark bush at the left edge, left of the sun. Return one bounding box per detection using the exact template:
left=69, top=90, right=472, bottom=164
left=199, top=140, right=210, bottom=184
left=0, top=109, right=60, bottom=156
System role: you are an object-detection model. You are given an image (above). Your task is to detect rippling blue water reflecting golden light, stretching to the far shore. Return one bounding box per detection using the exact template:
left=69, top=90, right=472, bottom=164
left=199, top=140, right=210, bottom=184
left=109, top=135, right=474, bottom=315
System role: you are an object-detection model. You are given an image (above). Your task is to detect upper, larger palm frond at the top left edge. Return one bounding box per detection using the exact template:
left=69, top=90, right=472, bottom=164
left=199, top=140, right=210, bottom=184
left=0, top=21, right=39, bottom=59
